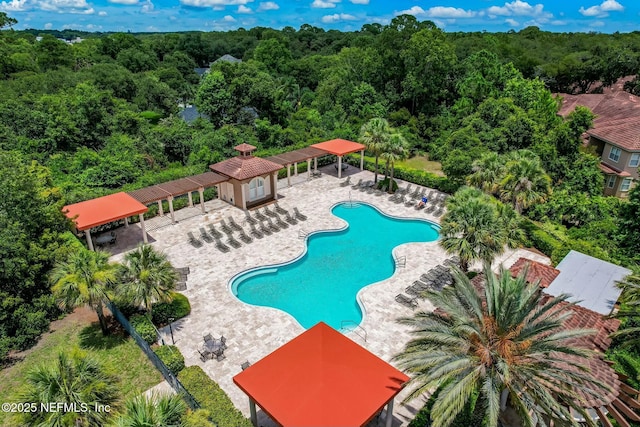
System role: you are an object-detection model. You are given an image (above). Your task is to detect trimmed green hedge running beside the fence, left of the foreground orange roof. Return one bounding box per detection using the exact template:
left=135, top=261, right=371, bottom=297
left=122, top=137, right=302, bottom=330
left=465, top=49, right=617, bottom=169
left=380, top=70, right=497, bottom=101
left=178, top=365, right=252, bottom=427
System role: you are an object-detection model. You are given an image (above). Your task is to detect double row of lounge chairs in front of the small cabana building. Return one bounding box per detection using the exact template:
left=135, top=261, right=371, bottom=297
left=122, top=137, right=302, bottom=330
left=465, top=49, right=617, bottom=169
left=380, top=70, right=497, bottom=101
left=187, top=202, right=307, bottom=253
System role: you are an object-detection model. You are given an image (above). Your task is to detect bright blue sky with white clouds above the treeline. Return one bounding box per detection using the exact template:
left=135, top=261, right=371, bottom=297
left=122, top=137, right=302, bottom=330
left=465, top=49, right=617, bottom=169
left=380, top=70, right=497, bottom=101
left=0, top=0, right=640, bottom=33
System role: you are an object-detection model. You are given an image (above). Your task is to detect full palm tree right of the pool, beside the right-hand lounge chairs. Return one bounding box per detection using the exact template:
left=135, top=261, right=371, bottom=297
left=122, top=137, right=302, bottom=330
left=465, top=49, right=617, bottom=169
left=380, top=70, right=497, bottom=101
left=440, top=187, right=512, bottom=271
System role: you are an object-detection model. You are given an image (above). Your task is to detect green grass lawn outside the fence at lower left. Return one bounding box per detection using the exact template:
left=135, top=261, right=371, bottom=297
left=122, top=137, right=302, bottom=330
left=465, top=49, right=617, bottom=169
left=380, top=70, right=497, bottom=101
left=0, top=309, right=163, bottom=426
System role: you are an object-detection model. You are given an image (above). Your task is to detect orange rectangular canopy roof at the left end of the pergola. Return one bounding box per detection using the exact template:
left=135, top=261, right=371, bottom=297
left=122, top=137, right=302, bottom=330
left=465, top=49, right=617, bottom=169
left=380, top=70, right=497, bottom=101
left=62, top=192, right=148, bottom=231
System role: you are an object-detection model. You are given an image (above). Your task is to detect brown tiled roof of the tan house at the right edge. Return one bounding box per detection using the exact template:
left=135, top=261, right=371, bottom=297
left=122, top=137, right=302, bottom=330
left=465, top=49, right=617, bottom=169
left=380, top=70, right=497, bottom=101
left=558, top=91, right=640, bottom=151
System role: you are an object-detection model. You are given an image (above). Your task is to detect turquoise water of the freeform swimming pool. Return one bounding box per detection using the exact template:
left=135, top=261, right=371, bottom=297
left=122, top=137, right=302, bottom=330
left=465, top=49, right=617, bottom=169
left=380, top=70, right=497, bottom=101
left=231, top=203, right=438, bottom=329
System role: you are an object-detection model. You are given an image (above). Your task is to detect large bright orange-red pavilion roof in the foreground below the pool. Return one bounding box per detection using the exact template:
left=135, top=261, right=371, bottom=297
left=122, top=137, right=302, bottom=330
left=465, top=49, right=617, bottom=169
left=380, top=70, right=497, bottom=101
left=233, top=322, right=409, bottom=427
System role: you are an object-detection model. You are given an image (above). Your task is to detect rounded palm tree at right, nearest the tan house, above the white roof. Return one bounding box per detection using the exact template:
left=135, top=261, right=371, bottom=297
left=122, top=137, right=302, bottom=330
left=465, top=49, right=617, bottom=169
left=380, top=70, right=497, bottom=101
left=500, top=150, right=551, bottom=213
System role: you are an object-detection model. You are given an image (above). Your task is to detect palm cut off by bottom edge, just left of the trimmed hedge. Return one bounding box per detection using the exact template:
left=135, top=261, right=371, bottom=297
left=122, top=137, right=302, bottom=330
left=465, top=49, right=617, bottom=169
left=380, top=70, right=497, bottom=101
left=114, top=394, right=186, bottom=427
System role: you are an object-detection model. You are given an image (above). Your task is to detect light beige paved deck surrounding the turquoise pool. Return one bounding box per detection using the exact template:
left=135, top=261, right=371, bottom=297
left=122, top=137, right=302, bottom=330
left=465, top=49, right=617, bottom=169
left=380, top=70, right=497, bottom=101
left=112, top=165, right=549, bottom=427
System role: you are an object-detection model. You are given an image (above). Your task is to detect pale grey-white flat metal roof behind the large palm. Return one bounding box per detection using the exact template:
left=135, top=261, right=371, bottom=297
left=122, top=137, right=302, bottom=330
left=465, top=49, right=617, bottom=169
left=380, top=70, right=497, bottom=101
left=546, top=251, right=631, bottom=315
